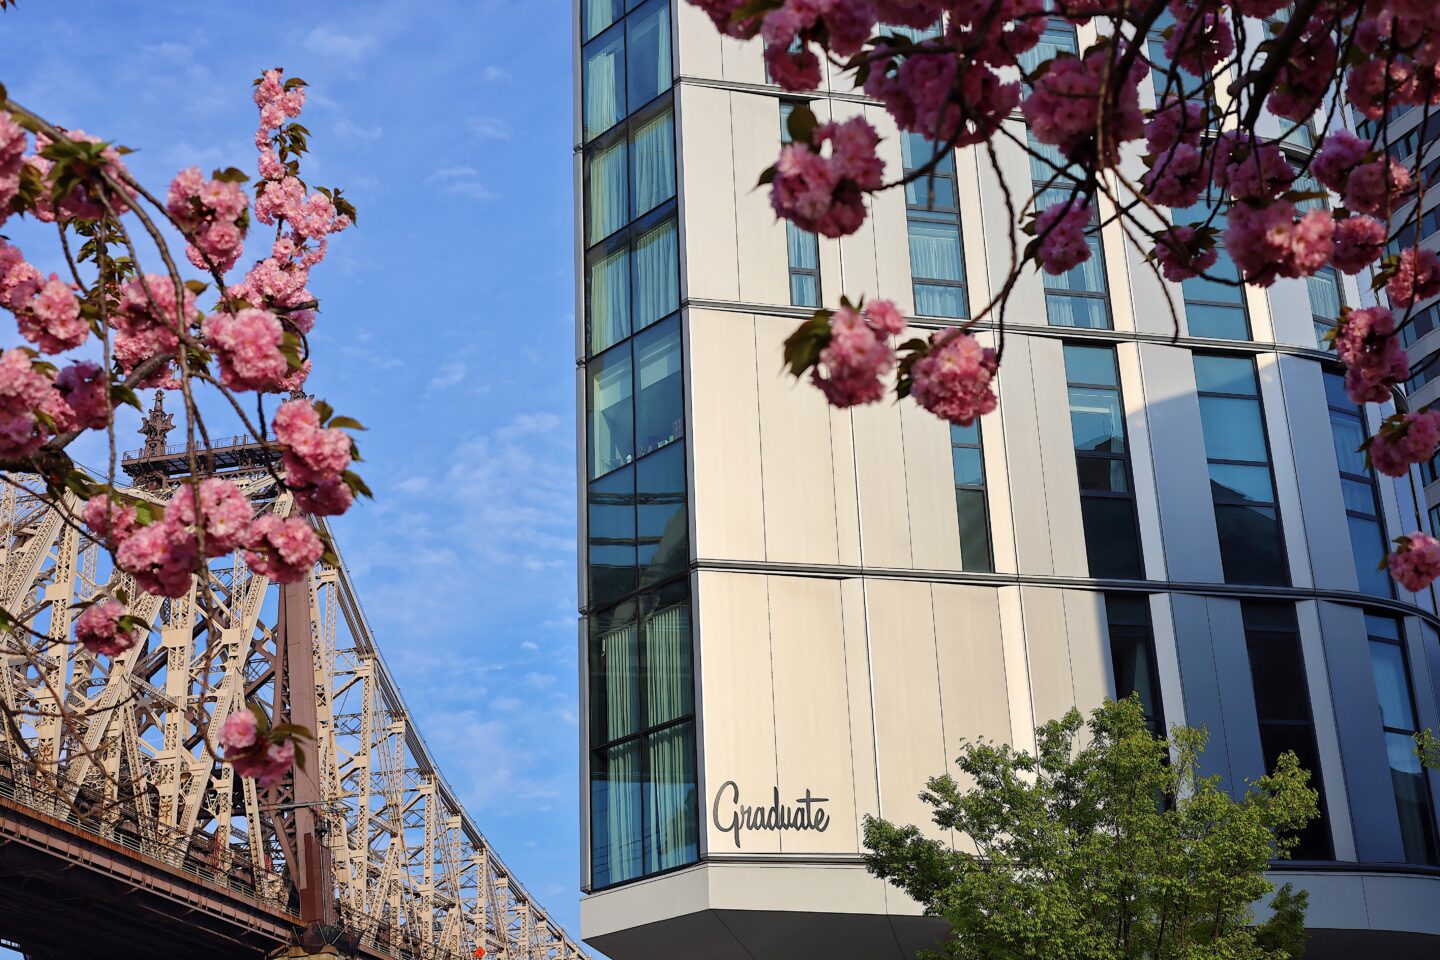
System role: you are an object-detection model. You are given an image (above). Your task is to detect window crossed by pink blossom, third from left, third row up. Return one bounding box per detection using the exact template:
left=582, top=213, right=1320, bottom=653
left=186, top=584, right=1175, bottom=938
left=1028, top=132, right=1112, bottom=330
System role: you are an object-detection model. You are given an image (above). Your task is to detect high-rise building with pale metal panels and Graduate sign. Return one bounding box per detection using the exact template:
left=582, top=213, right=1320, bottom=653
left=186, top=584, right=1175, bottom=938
left=575, top=0, right=1440, bottom=960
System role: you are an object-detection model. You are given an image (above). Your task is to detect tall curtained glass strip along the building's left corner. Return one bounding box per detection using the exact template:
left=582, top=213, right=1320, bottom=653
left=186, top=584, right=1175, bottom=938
left=580, top=0, right=700, bottom=889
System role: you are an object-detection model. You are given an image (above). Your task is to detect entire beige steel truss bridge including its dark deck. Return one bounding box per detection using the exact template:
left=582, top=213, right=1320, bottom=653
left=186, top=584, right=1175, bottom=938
left=0, top=396, right=585, bottom=960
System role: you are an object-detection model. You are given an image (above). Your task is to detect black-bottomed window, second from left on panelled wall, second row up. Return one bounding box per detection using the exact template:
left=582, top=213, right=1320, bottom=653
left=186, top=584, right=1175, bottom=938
left=1066, top=344, right=1145, bottom=580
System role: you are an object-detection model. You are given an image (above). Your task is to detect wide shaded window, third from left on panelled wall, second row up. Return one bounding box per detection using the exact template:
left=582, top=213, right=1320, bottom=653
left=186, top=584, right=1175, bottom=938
left=1195, top=354, right=1290, bottom=586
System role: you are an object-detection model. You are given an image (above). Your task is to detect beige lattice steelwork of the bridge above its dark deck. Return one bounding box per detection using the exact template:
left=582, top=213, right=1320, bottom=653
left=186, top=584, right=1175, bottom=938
left=0, top=466, right=585, bottom=960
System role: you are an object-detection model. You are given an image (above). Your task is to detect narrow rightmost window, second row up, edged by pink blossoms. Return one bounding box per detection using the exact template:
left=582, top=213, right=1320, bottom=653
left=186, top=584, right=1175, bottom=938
left=1325, top=370, right=1395, bottom=597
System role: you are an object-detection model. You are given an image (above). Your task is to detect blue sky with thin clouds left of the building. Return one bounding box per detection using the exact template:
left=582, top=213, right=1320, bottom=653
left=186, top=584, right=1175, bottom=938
left=0, top=0, right=579, bottom=934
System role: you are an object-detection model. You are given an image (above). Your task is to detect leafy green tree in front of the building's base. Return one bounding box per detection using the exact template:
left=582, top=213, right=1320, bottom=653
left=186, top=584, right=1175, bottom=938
left=865, top=698, right=1318, bottom=960
